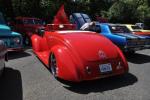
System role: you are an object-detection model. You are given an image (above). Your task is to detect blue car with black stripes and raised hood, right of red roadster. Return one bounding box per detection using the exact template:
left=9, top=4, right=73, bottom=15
left=72, top=13, right=150, bottom=53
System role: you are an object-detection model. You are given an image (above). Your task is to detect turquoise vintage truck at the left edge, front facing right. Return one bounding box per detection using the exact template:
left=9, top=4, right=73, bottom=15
left=0, top=13, right=23, bottom=51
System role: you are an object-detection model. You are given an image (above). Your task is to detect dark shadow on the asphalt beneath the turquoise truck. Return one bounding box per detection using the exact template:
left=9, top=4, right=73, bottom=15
left=8, top=51, right=31, bottom=60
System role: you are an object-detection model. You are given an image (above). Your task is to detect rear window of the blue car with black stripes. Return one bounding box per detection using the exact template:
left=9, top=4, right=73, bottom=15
left=109, top=25, right=131, bottom=33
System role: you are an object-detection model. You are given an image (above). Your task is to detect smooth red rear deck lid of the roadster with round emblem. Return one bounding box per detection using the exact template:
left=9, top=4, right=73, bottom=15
left=60, top=33, right=118, bottom=61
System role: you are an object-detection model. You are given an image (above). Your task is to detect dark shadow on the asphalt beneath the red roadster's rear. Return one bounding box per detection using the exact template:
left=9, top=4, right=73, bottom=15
left=64, top=73, right=138, bottom=94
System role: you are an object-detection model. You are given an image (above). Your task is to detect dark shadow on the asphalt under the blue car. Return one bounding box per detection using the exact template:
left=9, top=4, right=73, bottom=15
left=126, top=53, right=150, bottom=64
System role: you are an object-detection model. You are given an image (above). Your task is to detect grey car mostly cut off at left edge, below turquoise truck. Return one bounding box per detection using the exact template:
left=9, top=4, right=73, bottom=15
left=0, top=40, right=7, bottom=76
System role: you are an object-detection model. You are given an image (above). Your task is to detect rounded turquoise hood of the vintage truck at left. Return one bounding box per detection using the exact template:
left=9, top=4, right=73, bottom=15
left=0, top=25, right=20, bottom=36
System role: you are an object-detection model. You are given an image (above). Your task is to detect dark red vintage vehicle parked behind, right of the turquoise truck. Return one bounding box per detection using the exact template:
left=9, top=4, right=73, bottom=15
left=14, top=17, right=44, bottom=45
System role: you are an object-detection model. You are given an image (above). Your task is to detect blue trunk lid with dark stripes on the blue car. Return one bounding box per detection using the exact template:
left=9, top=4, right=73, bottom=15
left=115, top=33, right=145, bottom=39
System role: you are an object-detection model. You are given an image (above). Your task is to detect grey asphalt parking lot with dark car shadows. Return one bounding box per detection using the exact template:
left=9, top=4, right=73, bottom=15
left=0, top=49, right=150, bottom=100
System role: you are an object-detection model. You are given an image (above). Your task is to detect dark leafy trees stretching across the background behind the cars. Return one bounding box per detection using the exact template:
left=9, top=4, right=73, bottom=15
left=0, top=0, right=150, bottom=27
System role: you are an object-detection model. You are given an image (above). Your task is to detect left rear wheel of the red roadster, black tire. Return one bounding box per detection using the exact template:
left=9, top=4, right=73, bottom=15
left=50, top=53, right=58, bottom=78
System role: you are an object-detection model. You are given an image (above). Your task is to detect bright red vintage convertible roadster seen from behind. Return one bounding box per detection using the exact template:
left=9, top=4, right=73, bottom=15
left=31, top=5, right=128, bottom=82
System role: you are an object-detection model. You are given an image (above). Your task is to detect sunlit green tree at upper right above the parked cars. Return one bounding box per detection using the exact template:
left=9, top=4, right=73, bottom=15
left=108, top=0, right=149, bottom=23
